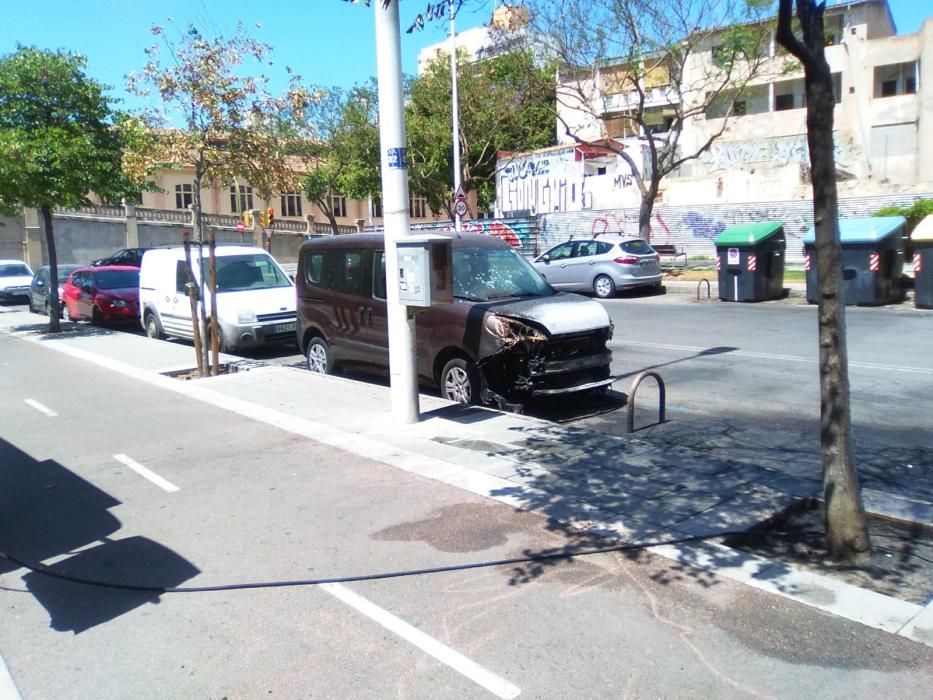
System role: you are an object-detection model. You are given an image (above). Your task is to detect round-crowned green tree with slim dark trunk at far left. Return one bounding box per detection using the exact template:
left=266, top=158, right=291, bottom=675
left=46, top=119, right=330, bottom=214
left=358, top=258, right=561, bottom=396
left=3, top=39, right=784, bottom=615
left=0, top=46, right=132, bottom=333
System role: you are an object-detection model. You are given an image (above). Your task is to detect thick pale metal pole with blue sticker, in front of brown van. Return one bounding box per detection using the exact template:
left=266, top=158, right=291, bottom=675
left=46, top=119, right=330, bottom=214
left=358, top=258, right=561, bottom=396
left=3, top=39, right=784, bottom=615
left=373, top=2, right=419, bottom=424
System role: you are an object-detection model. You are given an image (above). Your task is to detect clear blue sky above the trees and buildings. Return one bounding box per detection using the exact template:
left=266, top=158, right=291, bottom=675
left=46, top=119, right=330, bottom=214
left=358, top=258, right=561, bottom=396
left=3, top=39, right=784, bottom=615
left=0, top=0, right=933, bottom=112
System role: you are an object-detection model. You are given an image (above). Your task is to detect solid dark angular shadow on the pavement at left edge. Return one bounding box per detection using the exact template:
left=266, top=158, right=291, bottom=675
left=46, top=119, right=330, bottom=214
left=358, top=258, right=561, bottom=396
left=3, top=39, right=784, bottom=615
left=0, top=439, right=200, bottom=634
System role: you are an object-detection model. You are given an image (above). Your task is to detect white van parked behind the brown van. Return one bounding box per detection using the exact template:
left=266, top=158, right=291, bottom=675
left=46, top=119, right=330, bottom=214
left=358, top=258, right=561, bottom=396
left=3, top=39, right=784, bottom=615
left=139, top=245, right=296, bottom=351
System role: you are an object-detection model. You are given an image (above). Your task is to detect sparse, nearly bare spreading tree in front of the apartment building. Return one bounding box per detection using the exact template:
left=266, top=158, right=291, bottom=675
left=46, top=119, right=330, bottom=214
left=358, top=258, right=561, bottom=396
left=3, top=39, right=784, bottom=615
left=525, top=0, right=781, bottom=239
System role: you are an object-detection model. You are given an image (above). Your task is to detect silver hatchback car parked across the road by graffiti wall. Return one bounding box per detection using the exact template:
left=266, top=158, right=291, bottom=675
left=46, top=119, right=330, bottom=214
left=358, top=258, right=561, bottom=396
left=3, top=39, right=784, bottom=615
left=532, top=236, right=661, bottom=299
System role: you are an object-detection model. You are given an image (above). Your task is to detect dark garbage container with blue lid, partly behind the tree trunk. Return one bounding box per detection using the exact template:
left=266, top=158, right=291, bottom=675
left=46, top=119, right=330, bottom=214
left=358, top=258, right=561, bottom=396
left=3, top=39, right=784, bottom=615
left=803, top=216, right=907, bottom=306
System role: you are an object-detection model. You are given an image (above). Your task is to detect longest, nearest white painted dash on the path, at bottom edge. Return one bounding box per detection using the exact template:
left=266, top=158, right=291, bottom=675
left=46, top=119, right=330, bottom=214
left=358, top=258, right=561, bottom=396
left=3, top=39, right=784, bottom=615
left=319, top=583, right=522, bottom=698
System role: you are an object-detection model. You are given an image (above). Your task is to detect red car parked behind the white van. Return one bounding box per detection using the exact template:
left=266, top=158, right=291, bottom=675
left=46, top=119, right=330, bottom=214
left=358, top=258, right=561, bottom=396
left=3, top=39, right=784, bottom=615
left=62, top=265, right=139, bottom=324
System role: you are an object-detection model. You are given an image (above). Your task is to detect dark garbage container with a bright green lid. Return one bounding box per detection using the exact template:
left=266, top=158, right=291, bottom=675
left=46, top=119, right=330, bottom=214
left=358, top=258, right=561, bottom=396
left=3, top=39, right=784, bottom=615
left=715, top=221, right=787, bottom=301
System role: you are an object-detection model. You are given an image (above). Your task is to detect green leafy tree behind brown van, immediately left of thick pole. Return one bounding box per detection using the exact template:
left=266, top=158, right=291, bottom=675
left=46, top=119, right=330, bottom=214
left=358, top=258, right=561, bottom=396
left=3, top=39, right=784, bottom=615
left=284, top=84, right=382, bottom=234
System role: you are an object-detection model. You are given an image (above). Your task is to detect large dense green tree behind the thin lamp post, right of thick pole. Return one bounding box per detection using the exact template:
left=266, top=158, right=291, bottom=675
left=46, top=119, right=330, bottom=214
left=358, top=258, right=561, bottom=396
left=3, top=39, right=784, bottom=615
left=406, top=47, right=554, bottom=218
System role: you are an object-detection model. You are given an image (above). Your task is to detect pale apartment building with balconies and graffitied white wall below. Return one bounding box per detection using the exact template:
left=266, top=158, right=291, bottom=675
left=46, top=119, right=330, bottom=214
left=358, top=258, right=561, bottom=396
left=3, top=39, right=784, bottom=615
left=497, top=0, right=933, bottom=215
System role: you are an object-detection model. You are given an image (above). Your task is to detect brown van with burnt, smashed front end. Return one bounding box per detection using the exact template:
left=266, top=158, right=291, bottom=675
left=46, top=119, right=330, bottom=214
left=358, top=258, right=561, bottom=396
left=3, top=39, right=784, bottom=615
left=296, top=234, right=612, bottom=405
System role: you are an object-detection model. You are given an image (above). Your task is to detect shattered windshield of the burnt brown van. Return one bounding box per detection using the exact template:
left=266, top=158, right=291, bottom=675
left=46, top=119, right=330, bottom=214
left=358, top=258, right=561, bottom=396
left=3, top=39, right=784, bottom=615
left=453, top=247, right=554, bottom=301
